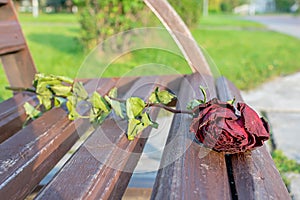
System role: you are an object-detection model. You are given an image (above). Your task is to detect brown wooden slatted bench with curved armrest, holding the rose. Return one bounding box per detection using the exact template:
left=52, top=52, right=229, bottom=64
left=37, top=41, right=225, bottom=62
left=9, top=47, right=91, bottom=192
left=0, top=0, right=290, bottom=199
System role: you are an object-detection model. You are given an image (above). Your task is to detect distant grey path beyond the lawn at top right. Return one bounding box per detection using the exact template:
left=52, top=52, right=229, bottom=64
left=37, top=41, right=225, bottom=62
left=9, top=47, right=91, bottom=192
left=246, top=15, right=300, bottom=38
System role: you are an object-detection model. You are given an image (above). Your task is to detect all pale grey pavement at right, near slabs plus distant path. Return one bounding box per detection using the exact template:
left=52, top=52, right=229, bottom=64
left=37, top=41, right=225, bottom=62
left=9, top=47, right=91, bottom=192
left=243, top=15, right=300, bottom=200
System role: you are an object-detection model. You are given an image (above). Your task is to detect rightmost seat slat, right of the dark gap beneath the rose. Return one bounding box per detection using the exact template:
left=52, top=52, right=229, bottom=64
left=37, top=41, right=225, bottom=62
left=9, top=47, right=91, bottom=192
left=217, top=77, right=290, bottom=199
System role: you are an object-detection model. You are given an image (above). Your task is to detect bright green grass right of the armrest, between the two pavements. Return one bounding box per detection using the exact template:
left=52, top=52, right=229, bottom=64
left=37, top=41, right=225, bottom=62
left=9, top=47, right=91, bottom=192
left=193, top=30, right=300, bottom=90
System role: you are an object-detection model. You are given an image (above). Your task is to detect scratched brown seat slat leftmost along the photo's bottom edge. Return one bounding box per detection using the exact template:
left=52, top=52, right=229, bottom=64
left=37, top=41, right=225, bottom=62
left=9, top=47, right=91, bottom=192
left=0, top=79, right=115, bottom=199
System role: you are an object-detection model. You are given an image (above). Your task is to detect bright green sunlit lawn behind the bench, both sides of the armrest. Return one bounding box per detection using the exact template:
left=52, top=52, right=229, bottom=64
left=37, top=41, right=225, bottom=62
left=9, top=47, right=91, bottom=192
left=0, top=14, right=300, bottom=100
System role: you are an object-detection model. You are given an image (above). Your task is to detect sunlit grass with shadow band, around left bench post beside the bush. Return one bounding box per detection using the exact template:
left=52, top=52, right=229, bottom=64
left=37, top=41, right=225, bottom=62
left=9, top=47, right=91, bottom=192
left=0, top=14, right=85, bottom=101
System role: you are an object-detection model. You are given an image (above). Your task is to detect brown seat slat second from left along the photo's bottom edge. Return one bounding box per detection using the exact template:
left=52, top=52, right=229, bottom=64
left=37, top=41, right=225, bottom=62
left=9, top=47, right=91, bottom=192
left=37, top=77, right=171, bottom=199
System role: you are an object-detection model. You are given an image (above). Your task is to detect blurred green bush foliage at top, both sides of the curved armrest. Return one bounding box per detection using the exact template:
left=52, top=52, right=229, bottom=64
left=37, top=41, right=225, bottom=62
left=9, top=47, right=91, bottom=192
left=78, top=0, right=202, bottom=50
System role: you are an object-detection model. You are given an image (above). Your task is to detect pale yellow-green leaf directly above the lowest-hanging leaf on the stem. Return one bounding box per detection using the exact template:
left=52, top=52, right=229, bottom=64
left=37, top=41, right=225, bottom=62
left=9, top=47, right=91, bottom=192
left=126, top=97, right=146, bottom=119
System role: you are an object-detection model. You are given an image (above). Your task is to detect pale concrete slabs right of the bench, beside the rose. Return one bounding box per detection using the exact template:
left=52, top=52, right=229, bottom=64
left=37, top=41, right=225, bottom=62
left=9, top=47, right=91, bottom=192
left=242, top=73, right=300, bottom=200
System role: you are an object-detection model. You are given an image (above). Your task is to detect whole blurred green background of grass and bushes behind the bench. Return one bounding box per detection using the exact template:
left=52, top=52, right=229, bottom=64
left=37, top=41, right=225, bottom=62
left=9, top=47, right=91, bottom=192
left=0, top=0, right=300, bottom=100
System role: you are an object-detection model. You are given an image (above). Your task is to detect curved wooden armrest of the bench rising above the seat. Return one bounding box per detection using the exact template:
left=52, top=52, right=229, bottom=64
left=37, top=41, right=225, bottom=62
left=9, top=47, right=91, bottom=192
left=144, top=0, right=211, bottom=75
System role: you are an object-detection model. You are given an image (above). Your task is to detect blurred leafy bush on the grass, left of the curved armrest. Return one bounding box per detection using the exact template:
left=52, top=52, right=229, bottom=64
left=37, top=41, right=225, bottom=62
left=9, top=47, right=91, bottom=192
left=79, top=0, right=144, bottom=49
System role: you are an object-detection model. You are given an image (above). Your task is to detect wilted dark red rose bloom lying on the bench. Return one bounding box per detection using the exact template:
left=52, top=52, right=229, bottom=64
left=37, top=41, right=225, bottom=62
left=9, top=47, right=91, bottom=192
left=190, top=98, right=270, bottom=154
